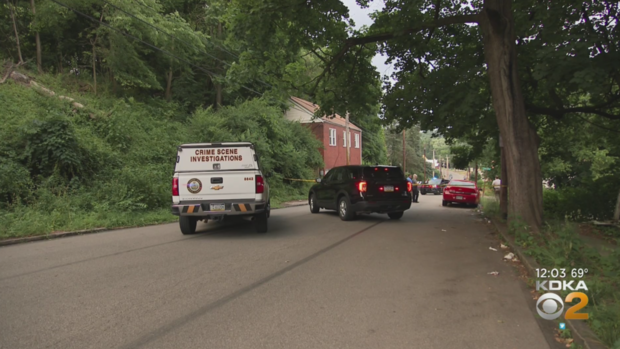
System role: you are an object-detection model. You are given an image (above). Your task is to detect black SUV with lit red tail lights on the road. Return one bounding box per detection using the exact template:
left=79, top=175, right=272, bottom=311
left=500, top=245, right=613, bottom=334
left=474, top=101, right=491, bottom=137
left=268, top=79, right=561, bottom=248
left=308, top=166, right=412, bottom=221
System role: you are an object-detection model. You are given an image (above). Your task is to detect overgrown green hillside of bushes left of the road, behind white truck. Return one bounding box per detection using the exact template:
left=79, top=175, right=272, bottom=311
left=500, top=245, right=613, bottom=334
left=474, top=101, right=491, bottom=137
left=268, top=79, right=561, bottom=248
left=0, top=71, right=322, bottom=238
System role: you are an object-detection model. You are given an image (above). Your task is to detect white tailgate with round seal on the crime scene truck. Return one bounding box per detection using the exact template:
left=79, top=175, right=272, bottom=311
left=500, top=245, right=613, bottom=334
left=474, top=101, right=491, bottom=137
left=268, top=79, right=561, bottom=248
left=179, top=171, right=256, bottom=201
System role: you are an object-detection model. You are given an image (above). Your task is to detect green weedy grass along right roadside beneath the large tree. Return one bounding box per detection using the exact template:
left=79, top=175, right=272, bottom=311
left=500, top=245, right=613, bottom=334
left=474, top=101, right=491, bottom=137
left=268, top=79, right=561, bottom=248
left=483, top=198, right=620, bottom=349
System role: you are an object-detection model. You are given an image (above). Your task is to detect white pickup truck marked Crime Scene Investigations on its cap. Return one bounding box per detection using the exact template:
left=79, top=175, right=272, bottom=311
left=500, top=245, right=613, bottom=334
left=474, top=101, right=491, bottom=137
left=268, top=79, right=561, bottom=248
left=172, top=142, right=271, bottom=235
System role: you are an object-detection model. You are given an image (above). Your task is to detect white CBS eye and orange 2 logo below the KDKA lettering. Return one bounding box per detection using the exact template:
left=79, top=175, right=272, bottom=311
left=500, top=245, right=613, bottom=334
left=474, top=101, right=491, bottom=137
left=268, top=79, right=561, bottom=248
left=536, top=292, right=589, bottom=320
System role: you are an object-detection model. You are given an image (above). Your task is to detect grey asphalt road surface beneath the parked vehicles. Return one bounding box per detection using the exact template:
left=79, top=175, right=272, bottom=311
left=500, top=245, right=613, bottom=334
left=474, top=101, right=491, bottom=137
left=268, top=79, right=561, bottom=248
left=0, top=195, right=549, bottom=349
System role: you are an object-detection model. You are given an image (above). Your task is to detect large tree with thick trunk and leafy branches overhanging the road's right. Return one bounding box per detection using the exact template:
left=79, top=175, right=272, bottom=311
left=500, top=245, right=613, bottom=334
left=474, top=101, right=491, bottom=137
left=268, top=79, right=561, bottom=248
left=224, top=0, right=620, bottom=231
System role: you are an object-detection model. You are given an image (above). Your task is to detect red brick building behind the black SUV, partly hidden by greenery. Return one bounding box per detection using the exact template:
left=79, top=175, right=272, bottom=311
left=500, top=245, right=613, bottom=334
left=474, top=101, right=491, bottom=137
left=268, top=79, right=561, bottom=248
left=284, top=97, right=362, bottom=173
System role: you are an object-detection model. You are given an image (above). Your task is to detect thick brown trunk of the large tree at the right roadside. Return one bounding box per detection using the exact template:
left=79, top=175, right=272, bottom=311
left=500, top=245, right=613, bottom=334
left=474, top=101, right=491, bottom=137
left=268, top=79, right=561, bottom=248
left=480, top=0, right=543, bottom=232
